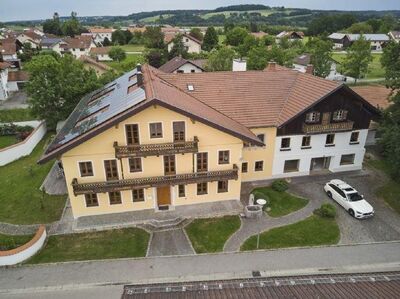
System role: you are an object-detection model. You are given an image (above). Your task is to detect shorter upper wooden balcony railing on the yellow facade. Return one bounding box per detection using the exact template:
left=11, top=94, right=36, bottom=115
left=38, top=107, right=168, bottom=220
left=114, top=136, right=199, bottom=159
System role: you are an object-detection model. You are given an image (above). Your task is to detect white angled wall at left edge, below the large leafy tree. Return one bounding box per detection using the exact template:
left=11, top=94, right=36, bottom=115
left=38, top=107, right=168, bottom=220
left=0, top=120, right=47, bottom=166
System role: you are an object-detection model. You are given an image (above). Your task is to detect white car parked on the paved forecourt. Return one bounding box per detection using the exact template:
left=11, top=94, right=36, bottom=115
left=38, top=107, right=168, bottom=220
left=324, top=180, right=374, bottom=219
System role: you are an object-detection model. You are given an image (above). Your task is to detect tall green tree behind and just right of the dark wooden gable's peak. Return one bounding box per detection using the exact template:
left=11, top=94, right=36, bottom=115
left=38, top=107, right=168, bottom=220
left=343, top=35, right=372, bottom=83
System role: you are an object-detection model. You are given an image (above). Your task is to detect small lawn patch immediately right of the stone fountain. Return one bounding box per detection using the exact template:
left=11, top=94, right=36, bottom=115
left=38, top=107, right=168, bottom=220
left=252, top=187, right=308, bottom=217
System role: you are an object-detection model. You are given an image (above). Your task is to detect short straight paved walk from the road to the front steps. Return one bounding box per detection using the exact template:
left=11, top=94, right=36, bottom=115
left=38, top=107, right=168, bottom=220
left=147, top=229, right=194, bottom=256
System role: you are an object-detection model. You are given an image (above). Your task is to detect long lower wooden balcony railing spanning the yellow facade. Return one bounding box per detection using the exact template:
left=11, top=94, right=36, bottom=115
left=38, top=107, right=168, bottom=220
left=72, top=164, right=238, bottom=195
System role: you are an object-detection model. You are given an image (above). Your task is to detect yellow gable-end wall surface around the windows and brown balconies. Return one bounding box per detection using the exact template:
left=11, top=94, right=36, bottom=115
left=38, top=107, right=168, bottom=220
left=61, top=106, right=247, bottom=217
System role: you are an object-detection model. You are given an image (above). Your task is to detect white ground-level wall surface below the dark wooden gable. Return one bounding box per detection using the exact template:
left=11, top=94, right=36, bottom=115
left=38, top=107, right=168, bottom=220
left=272, top=130, right=368, bottom=178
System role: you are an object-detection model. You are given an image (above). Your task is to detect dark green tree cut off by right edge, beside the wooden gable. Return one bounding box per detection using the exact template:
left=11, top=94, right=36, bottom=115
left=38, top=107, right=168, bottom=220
left=379, top=41, right=400, bottom=181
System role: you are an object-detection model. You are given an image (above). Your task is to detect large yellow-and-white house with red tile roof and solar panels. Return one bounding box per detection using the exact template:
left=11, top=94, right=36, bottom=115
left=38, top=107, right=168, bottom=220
left=39, top=63, right=378, bottom=218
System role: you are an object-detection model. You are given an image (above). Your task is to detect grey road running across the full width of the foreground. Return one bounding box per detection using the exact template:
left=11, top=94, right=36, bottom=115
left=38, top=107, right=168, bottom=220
left=0, top=242, right=400, bottom=298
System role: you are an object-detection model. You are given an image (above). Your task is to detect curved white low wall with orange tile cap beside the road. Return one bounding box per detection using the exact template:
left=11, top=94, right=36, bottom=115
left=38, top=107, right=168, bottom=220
left=0, top=225, right=47, bottom=266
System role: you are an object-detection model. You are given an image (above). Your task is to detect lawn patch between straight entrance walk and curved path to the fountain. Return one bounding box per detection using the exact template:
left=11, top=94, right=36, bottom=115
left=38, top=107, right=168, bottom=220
left=185, top=216, right=240, bottom=253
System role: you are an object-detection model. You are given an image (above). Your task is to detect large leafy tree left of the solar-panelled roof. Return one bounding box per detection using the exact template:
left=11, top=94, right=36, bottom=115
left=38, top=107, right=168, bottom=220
left=26, top=55, right=100, bottom=129
